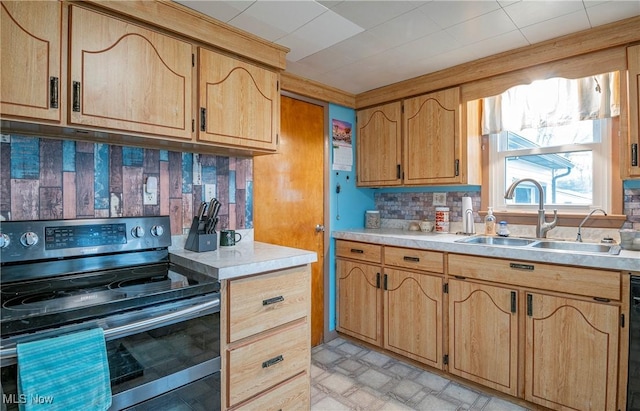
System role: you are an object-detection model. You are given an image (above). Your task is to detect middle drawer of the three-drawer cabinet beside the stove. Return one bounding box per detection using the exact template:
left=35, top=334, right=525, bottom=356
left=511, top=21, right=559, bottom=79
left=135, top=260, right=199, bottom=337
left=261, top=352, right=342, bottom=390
left=226, top=319, right=311, bottom=406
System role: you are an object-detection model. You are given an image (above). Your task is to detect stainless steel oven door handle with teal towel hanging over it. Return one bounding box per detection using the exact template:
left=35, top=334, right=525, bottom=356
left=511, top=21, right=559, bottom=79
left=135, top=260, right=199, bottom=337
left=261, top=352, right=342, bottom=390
left=0, top=298, right=220, bottom=362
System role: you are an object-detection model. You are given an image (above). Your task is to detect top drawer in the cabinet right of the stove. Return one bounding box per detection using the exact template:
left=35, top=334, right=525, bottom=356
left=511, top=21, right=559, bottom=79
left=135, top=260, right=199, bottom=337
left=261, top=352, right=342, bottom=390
left=227, top=266, right=311, bottom=342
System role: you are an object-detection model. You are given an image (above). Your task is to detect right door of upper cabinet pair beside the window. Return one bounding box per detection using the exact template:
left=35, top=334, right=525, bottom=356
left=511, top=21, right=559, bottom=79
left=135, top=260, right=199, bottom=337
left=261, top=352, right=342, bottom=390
left=404, top=87, right=463, bottom=184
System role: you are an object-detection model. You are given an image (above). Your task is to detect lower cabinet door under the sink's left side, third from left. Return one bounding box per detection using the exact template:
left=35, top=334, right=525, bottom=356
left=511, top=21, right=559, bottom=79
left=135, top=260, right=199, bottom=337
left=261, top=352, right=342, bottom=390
left=449, top=279, right=518, bottom=396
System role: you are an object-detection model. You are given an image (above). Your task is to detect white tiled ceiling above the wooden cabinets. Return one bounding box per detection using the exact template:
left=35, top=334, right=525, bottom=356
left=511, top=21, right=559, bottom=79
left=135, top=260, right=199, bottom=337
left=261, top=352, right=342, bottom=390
left=178, top=0, right=640, bottom=94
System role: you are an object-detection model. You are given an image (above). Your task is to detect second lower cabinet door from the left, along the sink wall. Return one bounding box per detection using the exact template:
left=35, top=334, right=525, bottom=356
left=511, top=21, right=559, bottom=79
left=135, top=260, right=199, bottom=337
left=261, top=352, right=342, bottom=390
left=383, top=269, right=442, bottom=369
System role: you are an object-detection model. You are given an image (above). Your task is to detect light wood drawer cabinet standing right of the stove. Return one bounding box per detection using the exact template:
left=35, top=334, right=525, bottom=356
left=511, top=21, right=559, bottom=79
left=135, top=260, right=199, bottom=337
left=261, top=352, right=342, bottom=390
left=220, top=266, right=311, bottom=410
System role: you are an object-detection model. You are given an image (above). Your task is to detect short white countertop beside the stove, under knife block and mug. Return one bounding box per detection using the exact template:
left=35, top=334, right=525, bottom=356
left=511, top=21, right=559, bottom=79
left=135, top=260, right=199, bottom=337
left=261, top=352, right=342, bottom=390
left=169, top=241, right=318, bottom=280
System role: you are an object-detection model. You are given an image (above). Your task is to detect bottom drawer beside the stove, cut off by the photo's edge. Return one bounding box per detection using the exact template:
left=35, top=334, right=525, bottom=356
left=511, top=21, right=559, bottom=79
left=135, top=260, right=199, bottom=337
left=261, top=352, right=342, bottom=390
left=234, top=372, right=311, bottom=411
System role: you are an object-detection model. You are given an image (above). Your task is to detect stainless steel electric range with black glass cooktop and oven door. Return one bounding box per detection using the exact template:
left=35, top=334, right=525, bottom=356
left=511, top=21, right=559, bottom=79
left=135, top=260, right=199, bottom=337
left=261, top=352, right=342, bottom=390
left=0, top=217, right=220, bottom=410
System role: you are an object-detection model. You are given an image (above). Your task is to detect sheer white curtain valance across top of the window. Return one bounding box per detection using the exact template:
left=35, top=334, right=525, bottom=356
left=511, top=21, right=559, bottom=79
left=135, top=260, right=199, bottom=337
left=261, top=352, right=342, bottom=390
left=482, top=71, right=620, bottom=134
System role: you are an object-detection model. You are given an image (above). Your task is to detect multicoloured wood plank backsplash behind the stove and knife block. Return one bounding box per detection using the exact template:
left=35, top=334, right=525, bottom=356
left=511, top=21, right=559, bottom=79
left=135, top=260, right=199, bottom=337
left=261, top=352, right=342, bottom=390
left=0, top=135, right=253, bottom=234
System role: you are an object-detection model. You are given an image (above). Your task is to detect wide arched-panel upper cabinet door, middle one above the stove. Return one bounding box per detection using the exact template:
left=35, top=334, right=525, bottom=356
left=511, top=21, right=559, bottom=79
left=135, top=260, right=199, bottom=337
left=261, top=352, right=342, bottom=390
left=69, top=6, right=193, bottom=139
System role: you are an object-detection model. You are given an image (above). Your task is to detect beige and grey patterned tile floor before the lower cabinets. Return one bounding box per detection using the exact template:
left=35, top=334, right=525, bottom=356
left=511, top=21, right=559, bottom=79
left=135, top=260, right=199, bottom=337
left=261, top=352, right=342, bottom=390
left=311, top=338, right=526, bottom=411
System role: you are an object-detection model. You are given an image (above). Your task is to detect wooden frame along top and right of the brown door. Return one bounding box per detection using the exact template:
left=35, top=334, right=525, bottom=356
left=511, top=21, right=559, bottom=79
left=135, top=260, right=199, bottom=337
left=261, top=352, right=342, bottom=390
left=280, top=90, right=338, bottom=343
